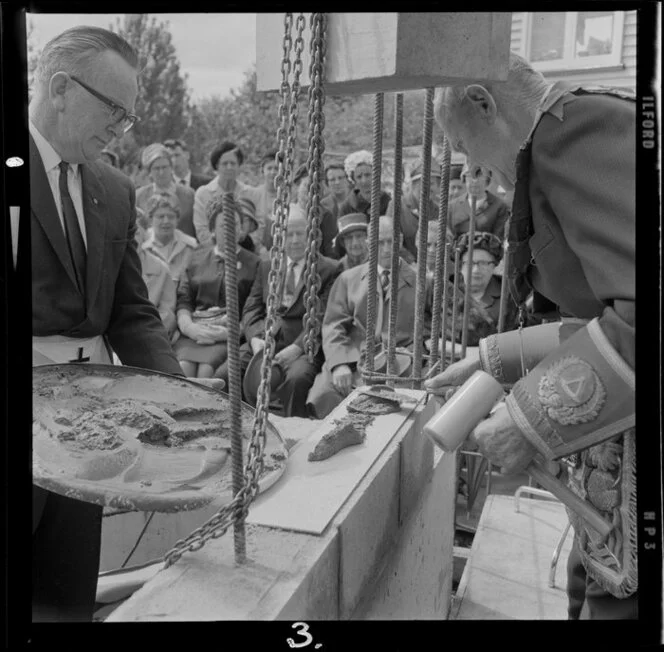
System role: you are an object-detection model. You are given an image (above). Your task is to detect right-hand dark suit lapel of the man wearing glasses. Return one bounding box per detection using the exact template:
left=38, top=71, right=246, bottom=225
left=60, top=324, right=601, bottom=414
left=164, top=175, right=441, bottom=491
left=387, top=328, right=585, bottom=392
left=80, top=164, right=111, bottom=306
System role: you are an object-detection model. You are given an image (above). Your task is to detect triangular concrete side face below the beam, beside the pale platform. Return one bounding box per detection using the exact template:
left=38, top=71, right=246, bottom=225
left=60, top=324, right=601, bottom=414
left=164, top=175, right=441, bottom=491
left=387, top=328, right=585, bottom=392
left=352, top=446, right=455, bottom=620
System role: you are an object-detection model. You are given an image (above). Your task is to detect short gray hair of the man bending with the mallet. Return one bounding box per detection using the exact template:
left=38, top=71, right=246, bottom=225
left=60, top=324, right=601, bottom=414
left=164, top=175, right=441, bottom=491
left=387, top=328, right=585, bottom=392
left=435, top=52, right=548, bottom=131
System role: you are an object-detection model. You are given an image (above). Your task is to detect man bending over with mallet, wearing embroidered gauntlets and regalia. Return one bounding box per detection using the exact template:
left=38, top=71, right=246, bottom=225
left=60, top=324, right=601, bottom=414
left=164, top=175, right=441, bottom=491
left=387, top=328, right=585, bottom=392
left=427, top=54, right=638, bottom=619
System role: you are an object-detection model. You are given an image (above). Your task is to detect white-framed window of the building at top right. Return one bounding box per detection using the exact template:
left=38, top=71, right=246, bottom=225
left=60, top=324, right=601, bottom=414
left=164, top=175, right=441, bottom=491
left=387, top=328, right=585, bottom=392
left=525, top=11, right=624, bottom=71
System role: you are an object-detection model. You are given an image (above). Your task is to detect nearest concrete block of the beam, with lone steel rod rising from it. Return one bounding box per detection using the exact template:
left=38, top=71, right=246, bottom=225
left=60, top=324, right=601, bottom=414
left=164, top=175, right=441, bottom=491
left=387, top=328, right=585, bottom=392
left=107, top=526, right=338, bottom=622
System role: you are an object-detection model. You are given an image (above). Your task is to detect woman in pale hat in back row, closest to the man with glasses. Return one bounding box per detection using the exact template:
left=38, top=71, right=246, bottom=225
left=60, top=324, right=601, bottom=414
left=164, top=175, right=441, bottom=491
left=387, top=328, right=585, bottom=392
left=136, top=143, right=196, bottom=238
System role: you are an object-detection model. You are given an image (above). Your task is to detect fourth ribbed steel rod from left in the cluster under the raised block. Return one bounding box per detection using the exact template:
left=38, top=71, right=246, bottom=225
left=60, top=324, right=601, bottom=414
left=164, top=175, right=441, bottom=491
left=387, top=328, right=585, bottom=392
left=429, top=138, right=452, bottom=372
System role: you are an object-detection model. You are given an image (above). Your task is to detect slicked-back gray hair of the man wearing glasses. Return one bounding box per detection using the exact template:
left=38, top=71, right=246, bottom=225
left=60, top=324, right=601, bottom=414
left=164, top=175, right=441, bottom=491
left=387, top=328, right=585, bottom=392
left=35, top=25, right=138, bottom=84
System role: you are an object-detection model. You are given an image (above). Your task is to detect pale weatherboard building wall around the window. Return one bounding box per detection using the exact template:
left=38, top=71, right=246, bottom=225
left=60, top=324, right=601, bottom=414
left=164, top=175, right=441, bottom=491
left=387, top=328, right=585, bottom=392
left=511, top=11, right=636, bottom=89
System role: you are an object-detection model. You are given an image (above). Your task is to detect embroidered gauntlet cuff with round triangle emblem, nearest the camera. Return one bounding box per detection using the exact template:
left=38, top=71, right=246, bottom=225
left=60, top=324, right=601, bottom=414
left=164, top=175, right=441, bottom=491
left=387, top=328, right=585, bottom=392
left=506, top=319, right=635, bottom=459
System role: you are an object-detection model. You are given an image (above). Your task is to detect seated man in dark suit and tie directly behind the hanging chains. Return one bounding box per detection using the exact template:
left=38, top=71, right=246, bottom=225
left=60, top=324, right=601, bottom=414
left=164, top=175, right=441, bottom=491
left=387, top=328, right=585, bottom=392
left=242, top=206, right=341, bottom=417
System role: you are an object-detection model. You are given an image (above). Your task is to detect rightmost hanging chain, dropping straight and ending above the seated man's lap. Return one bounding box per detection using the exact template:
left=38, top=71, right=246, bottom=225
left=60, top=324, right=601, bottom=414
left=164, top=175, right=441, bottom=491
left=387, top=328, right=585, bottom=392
left=303, top=13, right=327, bottom=363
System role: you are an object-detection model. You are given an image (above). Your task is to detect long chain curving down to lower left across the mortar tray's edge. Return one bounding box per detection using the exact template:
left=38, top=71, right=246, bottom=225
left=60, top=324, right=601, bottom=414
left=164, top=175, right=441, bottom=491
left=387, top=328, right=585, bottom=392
left=164, top=13, right=306, bottom=568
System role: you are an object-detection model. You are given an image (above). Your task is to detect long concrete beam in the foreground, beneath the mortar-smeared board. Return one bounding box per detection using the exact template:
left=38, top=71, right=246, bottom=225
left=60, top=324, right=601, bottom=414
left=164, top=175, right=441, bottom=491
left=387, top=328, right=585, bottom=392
left=106, top=392, right=454, bottom=622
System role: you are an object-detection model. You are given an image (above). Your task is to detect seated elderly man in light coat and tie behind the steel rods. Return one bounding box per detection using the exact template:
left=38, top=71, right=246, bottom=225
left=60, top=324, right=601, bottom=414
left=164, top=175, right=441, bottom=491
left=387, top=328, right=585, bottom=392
left=309, top=215, right=431, bottom=419
